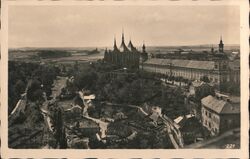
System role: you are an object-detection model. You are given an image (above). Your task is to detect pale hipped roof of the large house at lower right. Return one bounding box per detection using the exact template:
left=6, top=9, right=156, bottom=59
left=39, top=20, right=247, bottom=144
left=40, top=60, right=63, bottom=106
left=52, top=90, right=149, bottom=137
left=201, top=95, right=240, bottom=114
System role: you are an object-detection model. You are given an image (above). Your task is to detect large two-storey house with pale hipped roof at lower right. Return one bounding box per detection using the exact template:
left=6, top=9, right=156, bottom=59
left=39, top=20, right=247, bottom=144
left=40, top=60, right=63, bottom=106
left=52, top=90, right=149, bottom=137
left=201, top=95, right=240, bottom=136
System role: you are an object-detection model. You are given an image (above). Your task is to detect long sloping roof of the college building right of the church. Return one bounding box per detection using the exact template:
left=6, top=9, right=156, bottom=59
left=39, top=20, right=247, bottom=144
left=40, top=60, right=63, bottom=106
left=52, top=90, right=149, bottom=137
left=145, top=58, right=215, bottom=70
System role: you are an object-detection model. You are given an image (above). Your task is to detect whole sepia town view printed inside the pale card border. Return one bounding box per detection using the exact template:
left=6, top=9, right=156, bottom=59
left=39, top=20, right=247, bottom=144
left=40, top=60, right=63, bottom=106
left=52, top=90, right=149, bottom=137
left=2, top=0, right=249, bottom=158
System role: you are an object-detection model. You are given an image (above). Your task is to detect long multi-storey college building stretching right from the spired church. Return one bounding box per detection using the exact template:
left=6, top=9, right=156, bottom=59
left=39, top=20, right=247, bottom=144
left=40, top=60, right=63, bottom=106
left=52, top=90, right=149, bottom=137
left=140, top=40, right=240, bottom=84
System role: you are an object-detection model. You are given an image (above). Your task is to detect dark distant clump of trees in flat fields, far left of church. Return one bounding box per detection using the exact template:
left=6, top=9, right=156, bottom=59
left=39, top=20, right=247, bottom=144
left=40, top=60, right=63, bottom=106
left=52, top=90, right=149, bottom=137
left=37, top=50, right=71, bottom=58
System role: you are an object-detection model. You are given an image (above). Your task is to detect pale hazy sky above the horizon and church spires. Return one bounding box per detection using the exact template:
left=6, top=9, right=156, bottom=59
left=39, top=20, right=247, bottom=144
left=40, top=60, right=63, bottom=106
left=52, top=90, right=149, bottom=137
left=9, top=5, right=240, bottom=47
